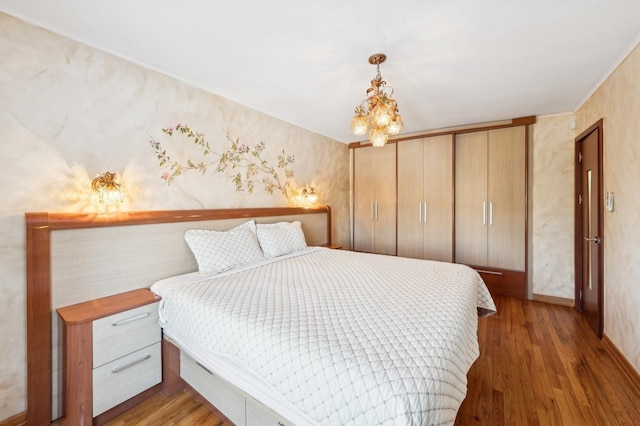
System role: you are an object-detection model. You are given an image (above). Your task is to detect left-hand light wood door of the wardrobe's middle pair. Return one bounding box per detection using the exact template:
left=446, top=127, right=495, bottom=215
left=398, top=139, right=425, bottom=259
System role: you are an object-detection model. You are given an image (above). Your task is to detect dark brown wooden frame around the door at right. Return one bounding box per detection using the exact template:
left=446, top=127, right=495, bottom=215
left=574, top=118, right=605, bottom=339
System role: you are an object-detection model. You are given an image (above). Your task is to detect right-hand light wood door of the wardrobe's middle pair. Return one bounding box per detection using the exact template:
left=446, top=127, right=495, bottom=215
left=423, top=135, right=453, bottom=262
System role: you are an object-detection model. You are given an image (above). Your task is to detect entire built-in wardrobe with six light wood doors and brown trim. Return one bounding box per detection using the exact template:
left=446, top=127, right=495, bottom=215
left=350, top=117, right=535, bottom=298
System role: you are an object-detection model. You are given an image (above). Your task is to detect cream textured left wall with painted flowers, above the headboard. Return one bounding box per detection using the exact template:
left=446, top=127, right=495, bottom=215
left=0, top=13, right=349, bottom=420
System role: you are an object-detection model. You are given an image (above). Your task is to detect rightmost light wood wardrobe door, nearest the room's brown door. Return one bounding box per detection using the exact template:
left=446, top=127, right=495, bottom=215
left=487, top=126, right=527, bottom=271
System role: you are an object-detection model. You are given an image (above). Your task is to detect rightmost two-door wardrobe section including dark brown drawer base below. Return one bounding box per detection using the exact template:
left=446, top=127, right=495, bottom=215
left=455, top=126, right=527, bottom=297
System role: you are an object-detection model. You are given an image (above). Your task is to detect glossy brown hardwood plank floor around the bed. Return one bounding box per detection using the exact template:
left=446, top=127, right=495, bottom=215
left=62, top=297, right=640, bottom=426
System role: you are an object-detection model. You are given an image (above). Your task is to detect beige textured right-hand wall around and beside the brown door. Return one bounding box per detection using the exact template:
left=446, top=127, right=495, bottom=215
left=576, top=40, right=640, bottom=371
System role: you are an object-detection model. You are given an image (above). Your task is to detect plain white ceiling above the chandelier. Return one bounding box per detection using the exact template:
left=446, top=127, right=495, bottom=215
left=0, top=0, right=640, bottom=143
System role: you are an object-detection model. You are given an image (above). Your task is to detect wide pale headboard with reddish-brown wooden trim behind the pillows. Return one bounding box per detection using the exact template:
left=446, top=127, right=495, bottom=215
left=26, top=206, right=331, bottom=425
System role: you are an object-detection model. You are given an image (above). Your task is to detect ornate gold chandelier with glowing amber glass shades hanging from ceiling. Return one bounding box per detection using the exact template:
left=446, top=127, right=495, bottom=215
left=351, top=53, right=402, bottom=147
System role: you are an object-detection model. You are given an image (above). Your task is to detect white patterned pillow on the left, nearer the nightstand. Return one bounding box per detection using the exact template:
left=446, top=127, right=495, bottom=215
left=184, top=224, right=264, bottom=274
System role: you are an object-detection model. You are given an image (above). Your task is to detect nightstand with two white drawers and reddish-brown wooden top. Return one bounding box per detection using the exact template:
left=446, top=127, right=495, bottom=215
left=58, top=289, right=162, bottom=425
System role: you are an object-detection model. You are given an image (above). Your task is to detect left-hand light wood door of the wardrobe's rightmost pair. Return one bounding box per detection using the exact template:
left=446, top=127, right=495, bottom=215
left=455, top=131, right=488, bottom=266
